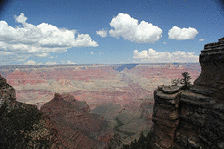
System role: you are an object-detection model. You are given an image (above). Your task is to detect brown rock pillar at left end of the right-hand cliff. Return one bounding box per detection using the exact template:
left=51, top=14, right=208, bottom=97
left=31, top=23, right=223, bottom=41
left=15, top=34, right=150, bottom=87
left=152, top=86, right=180, bottom=148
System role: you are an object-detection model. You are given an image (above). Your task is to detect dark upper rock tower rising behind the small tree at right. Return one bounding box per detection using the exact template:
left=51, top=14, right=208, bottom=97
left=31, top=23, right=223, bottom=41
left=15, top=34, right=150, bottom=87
left=194, top=37, right=224, bottom=95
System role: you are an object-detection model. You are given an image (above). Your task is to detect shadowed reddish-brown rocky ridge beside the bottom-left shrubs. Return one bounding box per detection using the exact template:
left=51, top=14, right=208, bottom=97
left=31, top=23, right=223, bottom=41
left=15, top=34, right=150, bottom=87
left=41, top=93, right=113, bottom=149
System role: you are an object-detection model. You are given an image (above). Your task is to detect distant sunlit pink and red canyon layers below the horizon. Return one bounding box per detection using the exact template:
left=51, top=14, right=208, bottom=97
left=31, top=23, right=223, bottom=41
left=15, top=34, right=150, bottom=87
left=0, top=63, right=200, bottom=109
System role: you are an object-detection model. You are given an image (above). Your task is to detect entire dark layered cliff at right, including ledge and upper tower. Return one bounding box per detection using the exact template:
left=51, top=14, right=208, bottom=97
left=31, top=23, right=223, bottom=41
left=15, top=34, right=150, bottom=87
left=152, top=38, right=224, bottom=149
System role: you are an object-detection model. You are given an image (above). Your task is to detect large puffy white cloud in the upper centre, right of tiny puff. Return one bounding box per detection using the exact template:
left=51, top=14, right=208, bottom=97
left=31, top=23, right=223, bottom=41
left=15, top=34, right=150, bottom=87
left=109, top=13, right=162, bottom=43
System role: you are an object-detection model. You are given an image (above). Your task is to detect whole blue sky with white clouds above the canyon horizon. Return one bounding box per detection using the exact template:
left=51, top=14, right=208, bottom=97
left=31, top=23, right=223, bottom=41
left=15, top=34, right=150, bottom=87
left=0, top=0, right=224, bottom=65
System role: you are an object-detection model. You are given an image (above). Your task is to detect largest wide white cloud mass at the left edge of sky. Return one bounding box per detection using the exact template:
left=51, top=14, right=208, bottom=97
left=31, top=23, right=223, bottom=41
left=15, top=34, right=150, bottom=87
left=0, top=13, right=98, bottom=63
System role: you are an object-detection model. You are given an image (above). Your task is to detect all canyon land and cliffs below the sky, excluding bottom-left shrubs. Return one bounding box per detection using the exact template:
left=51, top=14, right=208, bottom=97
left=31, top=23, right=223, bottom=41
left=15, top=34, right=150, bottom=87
left=0, top=38, right=224, bottom=149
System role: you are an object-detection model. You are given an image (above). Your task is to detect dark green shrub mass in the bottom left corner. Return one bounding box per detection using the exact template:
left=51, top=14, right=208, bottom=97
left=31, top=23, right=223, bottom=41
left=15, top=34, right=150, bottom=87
left=0, top=102, right=58, bottom=149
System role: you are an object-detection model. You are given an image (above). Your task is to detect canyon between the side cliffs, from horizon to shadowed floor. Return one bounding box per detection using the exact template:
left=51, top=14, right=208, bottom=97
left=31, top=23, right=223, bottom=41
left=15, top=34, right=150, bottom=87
left=0, top=63, right=201, bottom=148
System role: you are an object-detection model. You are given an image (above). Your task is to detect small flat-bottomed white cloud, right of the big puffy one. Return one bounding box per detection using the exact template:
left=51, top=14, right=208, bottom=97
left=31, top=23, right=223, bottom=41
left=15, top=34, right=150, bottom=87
left=168, top=26, right=198, bottom=40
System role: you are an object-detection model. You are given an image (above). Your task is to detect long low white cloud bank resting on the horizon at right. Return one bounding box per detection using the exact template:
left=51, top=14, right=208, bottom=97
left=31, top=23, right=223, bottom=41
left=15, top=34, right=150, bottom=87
left=133, top=49, right=199, bottom=63
